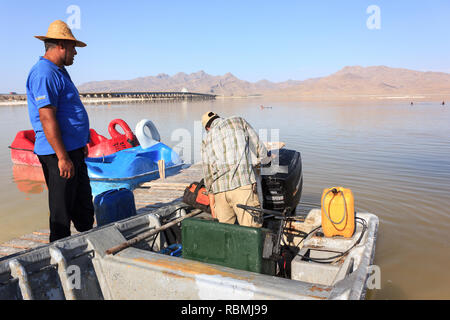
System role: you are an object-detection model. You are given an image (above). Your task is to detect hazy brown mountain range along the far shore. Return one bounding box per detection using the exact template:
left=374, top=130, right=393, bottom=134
left=78, top=66, right=450, bottom=98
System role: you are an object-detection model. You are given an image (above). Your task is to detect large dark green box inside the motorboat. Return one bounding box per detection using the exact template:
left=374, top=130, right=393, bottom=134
left=181, top=218, right=275, bottom=275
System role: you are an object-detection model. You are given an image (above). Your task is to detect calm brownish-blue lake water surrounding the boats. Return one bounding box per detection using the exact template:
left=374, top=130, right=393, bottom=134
left=0, top=99, right=450, bottom=299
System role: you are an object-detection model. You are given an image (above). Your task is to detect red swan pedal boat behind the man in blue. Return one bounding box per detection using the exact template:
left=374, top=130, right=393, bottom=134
left=9, top=119, right=139, bottom=167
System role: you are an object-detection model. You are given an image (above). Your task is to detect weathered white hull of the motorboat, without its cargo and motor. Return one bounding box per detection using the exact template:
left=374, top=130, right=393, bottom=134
left=0, top=204, right=378, bottom=300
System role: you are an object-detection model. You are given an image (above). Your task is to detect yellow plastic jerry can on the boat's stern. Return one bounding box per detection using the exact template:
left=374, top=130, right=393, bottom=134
left=321, top=187, right=355, bottom=238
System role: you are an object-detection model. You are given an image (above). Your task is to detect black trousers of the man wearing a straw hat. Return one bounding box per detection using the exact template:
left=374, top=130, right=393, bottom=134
left=38, top=148, right=94, bottom=242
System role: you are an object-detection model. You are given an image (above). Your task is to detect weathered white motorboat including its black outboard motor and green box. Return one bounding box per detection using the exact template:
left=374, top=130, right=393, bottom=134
left=0, top=150, right=379, bottom=300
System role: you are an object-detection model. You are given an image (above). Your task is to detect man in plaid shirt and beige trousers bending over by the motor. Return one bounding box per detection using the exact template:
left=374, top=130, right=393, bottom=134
left=201, top=111, right=270, bottom=227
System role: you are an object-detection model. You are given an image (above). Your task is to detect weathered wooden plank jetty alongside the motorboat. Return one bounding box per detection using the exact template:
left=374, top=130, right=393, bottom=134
left=0, top=163, right=203, bottom=258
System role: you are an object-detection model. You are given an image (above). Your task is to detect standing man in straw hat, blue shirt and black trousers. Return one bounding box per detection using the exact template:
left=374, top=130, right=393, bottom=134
left=27, top=20, right=94, bottom=242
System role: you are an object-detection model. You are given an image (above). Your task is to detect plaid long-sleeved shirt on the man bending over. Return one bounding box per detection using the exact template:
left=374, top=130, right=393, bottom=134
left=201, top=117, right=270, bottom=194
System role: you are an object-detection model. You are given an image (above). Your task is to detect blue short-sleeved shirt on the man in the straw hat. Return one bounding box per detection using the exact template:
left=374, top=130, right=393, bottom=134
left=27, top=57, right=89, bottom=155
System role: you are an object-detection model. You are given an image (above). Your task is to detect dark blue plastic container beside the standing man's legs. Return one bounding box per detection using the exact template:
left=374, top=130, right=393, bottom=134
left=94, top=189, right=136, bottom=227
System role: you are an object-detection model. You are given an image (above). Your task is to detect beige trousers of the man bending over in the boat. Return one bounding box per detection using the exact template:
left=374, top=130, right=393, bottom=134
left=214, top=185, right=262, bottom=228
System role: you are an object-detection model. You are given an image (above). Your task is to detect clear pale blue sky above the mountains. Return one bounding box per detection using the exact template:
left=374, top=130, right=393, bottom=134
left=0, top=0, right=450, bottom=93
